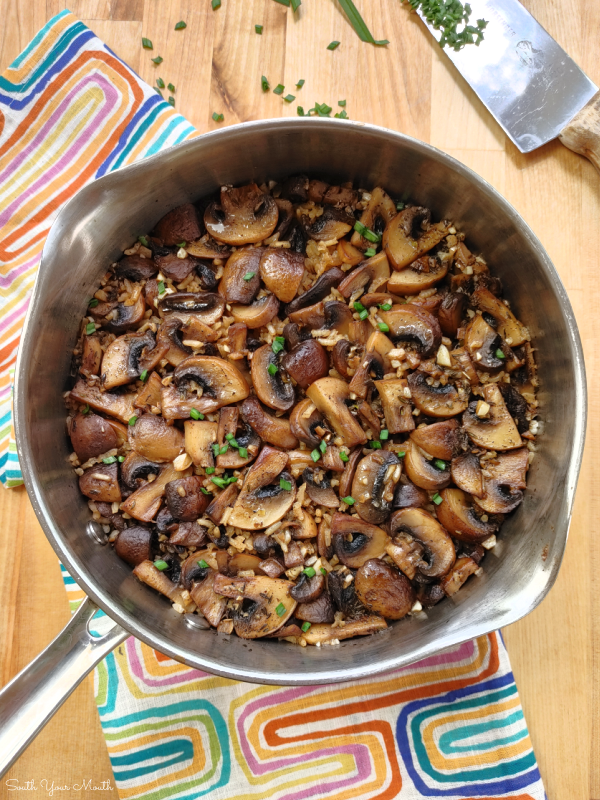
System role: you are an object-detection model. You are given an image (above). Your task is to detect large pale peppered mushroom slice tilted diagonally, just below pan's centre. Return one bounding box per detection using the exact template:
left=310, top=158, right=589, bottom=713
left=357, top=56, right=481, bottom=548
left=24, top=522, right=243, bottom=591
left=228, top=445, right=296, bottom=531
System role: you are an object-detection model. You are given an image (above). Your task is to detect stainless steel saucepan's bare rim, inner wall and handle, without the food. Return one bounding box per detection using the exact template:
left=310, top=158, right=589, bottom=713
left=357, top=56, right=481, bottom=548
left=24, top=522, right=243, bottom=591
left=0, top=119, right=586, bottom=773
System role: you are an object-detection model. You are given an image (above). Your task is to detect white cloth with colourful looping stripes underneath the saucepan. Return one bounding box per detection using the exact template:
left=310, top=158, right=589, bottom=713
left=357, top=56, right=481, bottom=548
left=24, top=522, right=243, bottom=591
left=0, top=12, right=545, bottom=800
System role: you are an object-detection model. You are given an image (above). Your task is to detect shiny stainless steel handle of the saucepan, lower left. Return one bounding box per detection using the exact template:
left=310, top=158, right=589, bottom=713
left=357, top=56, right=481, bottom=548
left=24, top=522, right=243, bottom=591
left=0, top=597, right=129, bottom=777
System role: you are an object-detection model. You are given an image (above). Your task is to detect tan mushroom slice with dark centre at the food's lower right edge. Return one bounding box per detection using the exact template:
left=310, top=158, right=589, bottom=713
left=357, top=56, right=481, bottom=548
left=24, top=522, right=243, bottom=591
left=476, top=447, right=529, bottom=514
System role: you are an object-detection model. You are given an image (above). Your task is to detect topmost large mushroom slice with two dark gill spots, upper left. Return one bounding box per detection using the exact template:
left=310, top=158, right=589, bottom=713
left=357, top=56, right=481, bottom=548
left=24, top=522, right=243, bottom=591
left=204, top=183, right=279, bottom=247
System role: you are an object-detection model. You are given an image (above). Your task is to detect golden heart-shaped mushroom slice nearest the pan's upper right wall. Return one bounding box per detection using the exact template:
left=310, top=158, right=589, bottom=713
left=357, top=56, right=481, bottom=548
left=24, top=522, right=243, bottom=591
left=382, top=206, right=448, bottom=269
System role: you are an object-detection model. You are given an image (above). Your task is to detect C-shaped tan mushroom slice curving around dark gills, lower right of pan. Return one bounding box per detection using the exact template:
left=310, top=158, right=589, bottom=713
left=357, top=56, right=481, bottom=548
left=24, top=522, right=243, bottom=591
left=390, top=508, right=456, bottom=578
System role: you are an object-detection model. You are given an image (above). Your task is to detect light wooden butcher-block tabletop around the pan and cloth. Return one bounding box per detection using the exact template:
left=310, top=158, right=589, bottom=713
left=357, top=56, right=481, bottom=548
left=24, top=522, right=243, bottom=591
left=0, top=0, right=600, bottom=800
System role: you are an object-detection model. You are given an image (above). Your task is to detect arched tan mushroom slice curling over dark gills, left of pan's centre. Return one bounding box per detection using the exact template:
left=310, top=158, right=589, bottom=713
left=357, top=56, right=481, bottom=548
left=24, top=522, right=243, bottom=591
left=173, top=356, right=250, bottom=413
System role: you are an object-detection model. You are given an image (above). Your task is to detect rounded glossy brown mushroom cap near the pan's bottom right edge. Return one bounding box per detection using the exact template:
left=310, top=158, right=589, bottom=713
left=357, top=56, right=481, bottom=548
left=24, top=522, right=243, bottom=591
left=355, top=558, right=416, bottom=619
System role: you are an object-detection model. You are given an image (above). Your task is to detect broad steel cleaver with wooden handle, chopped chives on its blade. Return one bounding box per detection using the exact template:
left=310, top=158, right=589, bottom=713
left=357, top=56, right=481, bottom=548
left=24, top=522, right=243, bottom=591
left=414, top=0, right=600, bottom=171
